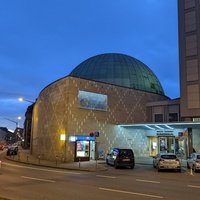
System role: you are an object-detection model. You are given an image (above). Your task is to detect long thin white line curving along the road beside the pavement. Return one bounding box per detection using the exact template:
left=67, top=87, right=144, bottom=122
left=4, top=162, right=81, bottom=175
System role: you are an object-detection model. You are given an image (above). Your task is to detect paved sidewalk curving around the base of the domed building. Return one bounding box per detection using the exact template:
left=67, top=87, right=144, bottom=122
left=3, top=149, right=186, bottom=172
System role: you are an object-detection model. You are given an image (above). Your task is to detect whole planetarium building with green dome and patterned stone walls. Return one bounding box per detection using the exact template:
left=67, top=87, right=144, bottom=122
left=31, top=53, right=195, bottom=162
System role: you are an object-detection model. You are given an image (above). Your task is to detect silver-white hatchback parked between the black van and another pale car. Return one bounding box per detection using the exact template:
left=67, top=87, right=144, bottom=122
left=153, top=153, right=181, bottom=172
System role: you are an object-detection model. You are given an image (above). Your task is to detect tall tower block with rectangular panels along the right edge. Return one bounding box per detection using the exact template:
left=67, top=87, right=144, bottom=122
left=178, top=0, right=200, bottom=121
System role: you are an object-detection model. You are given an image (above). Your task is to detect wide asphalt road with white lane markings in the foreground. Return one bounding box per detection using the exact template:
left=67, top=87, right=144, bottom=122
left=0, top=155, right=200, bottom=200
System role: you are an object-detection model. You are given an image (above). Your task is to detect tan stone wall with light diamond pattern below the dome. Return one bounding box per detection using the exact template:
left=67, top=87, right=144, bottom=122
left=31, top=76, right=167, bottom=161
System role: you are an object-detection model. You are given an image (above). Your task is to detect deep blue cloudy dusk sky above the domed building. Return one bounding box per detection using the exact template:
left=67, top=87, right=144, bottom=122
left=0, top=0, right=180, bottom=129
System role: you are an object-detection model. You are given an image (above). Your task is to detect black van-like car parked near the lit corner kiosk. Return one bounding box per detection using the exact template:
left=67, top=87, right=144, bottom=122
left=106, top=148, right=135, bottom=169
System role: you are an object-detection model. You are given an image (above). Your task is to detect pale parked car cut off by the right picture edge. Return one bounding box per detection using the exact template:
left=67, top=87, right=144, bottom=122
left=187, top=153, right=200, bottom=172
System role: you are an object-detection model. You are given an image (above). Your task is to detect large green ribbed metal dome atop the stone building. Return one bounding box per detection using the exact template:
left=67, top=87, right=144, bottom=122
left=70, top=53, right=164, bottom=95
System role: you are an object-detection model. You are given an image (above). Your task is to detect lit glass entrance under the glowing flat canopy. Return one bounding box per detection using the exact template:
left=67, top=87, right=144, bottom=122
left=121, top=123, right=200, bottom=158
